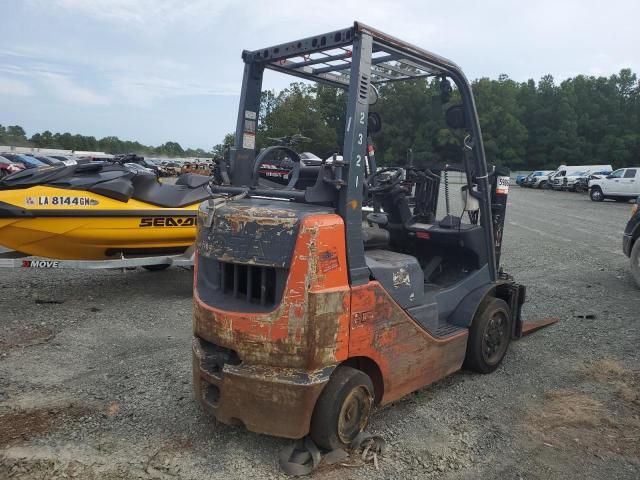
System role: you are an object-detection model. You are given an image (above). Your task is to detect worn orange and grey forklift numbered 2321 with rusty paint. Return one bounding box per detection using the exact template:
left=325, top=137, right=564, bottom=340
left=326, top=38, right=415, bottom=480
left=192, top=22, right=541, bottom=450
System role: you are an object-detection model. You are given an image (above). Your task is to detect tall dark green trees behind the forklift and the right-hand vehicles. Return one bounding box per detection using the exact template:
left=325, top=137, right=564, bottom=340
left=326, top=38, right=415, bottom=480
left=244, top=69, right=640, bottom=170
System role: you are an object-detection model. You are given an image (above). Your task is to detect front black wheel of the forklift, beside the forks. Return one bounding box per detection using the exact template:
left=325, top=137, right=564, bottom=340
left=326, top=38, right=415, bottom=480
left=464, top=297, right=513, bottom=373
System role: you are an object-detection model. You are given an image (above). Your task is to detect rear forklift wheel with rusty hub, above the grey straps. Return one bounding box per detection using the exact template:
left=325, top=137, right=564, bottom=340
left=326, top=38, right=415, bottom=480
left=310, top=365, right=374, bottom=450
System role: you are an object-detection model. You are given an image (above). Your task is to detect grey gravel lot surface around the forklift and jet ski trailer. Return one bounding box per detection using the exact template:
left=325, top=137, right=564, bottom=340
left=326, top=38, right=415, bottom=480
left=0, top=187, right=640, bottom=479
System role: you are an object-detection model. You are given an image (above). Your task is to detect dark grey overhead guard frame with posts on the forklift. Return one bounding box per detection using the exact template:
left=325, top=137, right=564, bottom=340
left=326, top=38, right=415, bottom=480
left=225, top=22, right=504, bottom=285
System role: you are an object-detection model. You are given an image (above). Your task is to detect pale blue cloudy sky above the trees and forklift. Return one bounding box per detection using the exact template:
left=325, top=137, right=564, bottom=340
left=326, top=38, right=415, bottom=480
left=0, top=0, right=640, bottom=150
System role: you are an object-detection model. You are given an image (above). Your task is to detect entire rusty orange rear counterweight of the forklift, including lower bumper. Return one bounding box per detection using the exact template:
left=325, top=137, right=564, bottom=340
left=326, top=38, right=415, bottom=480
left=193, top=214, right=350, bottom=438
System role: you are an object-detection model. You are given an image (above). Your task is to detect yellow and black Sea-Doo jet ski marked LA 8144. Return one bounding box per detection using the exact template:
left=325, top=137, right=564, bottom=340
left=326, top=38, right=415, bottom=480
left=0, top=162, right=211, bottom=260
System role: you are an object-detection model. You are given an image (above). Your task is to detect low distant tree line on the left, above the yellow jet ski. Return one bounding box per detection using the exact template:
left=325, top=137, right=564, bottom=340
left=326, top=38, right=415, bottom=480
left=0, top=125, right=212, bottom=158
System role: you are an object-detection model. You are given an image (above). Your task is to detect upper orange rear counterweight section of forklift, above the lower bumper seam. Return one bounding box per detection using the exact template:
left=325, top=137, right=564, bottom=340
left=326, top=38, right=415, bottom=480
left=194, top=215, right=349, bottom=370
